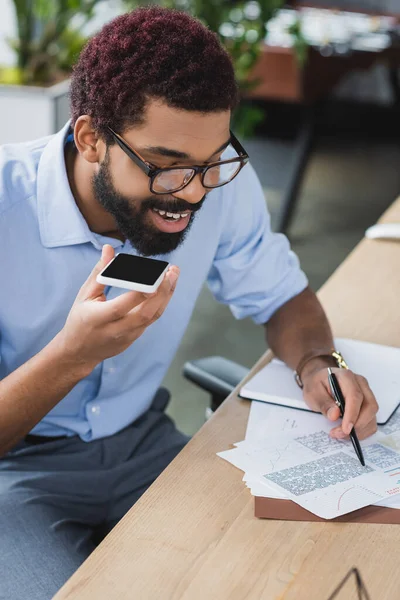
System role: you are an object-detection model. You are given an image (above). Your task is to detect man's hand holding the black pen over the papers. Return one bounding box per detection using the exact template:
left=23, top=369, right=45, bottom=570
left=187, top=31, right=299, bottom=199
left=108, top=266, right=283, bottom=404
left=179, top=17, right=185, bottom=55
left=302, top=365, right=378, bottom=440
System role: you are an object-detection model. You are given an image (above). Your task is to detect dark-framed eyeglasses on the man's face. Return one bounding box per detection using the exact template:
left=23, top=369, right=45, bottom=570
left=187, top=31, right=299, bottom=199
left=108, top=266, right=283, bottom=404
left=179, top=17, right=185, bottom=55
left=107, top=127, right=249, bottom=194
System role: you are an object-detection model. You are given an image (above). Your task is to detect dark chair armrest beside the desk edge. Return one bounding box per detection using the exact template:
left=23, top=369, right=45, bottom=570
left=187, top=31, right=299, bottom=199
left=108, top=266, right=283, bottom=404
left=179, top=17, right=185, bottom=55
left=183, top=356, right=249, bottom=398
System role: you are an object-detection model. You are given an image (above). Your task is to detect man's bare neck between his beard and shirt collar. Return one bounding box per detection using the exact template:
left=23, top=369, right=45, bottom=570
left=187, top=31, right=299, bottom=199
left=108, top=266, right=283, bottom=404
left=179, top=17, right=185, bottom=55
left=64, top=143, right=125, bottom=241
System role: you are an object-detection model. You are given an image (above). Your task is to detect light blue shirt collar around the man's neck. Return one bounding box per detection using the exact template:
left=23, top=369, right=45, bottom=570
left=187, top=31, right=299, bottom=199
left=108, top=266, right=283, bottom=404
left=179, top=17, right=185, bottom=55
left=37, top=122, right=114, bottom=249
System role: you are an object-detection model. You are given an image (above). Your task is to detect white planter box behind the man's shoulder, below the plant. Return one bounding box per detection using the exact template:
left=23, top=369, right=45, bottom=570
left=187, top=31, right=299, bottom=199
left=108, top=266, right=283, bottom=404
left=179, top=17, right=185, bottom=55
left=0, top=80, right=69, bottom=144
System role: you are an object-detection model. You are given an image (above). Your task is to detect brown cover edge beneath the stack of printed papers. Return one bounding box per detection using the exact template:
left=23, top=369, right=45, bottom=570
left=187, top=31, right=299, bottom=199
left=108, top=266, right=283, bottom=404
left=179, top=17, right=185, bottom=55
left=254, top=496, right=400, bottom=525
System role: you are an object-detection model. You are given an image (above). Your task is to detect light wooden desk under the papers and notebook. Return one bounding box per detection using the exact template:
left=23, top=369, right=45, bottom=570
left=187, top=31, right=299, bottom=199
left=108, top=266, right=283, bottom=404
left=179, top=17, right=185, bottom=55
left=55, top=200, right=400, bottom=600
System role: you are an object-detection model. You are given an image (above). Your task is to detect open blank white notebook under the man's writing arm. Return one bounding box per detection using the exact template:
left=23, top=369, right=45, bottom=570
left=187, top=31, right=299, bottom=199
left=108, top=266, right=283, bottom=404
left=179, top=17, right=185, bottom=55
left=240, top=338, right=400, bottom=425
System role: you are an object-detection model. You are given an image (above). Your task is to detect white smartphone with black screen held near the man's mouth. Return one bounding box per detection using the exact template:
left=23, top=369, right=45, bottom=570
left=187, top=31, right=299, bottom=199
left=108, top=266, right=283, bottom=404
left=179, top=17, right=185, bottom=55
left=96, top=252, right=169, bottom=294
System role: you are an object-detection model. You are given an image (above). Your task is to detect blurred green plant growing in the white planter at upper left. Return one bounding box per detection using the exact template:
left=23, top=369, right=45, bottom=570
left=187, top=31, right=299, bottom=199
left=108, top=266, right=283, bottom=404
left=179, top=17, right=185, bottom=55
left=0, top=0, right=101, bottom=85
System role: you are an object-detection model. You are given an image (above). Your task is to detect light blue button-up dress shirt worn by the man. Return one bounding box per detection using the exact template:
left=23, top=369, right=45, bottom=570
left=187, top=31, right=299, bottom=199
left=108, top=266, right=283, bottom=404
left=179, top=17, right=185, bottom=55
left=0, top=124, right=307, bottom=441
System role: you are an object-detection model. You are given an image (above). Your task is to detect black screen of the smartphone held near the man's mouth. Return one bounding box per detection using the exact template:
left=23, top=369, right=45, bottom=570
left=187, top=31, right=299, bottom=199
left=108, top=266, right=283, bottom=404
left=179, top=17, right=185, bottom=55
left=102, top=254, right=168, bottom=285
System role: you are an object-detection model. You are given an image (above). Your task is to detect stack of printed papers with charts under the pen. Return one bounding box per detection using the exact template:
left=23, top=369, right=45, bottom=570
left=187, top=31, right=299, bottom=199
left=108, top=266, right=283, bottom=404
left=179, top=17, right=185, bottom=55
left=218, top=402, right=400, bottom=519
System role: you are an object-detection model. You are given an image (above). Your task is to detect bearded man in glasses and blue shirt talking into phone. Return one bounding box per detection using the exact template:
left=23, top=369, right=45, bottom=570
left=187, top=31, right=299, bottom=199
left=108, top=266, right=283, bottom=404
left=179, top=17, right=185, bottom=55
left=0, top=8, right=377, bottom=600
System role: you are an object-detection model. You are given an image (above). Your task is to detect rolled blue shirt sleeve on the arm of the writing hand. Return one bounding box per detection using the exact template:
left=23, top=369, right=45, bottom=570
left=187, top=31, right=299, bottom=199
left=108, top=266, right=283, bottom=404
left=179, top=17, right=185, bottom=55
left=207, top=165, right=308, bottom=324
